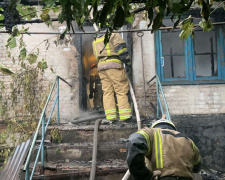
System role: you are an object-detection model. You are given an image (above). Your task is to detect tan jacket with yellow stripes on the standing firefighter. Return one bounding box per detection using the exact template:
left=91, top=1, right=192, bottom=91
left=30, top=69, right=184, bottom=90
left=92, top=33, right=130, bottom=71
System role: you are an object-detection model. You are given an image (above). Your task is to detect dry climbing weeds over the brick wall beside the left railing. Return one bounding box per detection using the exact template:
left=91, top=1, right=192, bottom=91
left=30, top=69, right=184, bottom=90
left=0, top=66, right=47, bottom=169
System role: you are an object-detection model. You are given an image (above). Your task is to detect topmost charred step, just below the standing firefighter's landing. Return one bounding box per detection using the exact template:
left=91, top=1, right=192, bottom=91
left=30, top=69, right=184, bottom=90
left=44, top=123, right=137, bottom=143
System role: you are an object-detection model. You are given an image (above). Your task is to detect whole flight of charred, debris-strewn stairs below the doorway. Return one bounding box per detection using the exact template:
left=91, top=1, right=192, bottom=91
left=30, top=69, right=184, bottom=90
left=20, top=120, right=137, bottom=180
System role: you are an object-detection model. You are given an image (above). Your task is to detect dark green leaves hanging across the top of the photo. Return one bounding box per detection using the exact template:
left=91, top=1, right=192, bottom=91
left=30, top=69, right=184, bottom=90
left=30, top=0, right=224, bottom=43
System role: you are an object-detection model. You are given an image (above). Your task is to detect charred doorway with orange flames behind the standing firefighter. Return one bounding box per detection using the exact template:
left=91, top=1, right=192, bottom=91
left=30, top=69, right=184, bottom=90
left=73, top=25, right=132, bottom=111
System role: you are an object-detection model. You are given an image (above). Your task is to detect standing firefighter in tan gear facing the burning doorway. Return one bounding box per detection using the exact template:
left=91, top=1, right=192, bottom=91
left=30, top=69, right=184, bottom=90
left=92, top=33, right=132, bottom=121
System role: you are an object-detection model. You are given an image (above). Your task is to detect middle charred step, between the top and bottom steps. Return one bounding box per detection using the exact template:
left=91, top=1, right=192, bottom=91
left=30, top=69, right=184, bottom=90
left=31, top=141, right=126, bottom=162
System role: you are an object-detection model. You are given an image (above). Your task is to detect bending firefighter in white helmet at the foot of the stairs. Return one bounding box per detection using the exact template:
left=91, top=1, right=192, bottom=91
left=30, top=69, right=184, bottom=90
left=126, top=119, right=201, bottom=180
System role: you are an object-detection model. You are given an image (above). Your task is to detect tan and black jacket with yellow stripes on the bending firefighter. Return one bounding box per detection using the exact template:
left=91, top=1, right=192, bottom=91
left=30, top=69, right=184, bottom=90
left=127, top=128, right=201, bottom=178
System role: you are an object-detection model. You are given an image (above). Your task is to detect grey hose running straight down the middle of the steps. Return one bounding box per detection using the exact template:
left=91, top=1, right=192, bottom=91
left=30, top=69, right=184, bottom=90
left=90, top=119, right=102, bottom=180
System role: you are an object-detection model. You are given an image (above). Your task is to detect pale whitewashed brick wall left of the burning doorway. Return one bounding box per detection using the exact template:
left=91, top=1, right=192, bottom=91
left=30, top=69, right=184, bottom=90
left=0, top=22, right=79, bottom=120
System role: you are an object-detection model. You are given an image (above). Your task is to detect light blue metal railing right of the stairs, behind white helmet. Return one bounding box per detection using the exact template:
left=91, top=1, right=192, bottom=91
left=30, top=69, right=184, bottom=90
left=147, top=74, right=171, bottom=121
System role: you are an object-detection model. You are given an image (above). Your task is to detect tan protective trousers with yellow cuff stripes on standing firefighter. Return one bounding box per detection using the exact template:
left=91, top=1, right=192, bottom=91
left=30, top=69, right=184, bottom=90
left=99, top=68, right=132, bottom=121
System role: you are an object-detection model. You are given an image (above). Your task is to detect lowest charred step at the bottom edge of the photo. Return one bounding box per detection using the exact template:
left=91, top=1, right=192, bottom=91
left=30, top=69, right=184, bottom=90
left=20, top=159, right=130, bottom=180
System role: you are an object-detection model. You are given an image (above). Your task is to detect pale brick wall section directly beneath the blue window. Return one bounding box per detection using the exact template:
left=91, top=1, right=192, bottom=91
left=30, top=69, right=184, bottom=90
left=163, top=84, right=225, bottom=115
